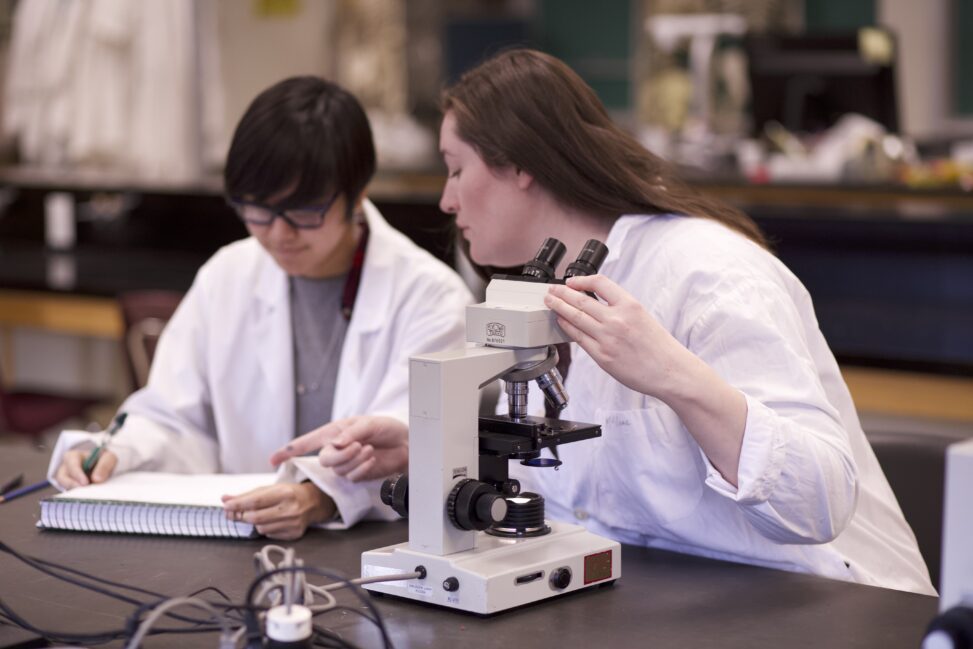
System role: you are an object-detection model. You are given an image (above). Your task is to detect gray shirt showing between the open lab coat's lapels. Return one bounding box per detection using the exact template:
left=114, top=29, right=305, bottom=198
left=290, top=275, right=348, bottom=435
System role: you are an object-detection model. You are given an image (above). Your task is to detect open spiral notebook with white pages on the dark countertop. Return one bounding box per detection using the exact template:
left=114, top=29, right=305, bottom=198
left=37, top=472, right=276, bottom=538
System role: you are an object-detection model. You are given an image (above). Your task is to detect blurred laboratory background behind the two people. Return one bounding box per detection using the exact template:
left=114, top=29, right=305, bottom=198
left=0, top=0, right=973, bottom=444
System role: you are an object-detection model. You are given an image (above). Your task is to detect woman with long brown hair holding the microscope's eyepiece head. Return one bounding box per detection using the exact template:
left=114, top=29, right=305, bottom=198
left=440, top=50, right=934, bottom=593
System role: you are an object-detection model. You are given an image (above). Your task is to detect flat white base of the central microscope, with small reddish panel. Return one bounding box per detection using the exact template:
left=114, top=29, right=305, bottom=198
left=361, top=522, right=622, bottom=614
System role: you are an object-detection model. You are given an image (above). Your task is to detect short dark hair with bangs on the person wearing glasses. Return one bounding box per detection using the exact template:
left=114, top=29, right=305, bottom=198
left=223, top=76, right=375, bottom=216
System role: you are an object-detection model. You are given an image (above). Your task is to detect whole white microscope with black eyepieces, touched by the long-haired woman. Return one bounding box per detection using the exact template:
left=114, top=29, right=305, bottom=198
left=361, top=239, right=621, bottom=614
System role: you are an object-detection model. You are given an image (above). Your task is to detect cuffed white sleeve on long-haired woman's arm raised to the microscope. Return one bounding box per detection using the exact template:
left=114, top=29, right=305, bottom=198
left=689, top=278, right=858, bottom=543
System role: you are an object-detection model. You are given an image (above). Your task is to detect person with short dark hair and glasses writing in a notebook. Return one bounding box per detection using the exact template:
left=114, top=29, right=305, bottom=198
left=50, top=77, right=472, bottom=539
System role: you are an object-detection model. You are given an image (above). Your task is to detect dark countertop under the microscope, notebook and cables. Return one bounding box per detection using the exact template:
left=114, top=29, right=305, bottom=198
left=0, top=446, right=938, bottom=649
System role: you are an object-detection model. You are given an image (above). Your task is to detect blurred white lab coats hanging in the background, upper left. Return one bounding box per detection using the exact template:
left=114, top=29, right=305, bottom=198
left=3, top=0, right=227, bottom=180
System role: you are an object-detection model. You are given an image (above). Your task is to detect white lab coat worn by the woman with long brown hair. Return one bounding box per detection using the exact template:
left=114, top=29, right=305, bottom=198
left=511, top=216, right=935, bottom=594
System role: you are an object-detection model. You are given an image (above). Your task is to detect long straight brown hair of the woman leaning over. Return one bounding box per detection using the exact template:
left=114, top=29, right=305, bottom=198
left=441, top=49, right=767, bottom=247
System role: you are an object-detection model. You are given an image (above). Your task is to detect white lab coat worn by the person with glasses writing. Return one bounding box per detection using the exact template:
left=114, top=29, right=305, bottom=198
left=49, top=201, right=472, bottom=526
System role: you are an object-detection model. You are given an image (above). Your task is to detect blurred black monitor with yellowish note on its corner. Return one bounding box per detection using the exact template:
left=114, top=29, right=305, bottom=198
left=744, top=27, right=899, bottom=135
